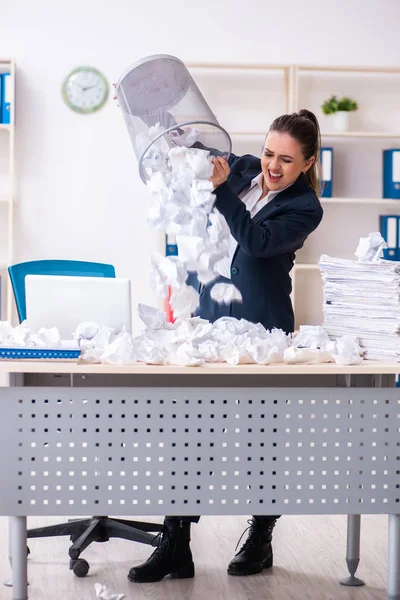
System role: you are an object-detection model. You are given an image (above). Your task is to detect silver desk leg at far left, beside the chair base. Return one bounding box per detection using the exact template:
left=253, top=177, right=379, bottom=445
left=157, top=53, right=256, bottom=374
left=9, top=517, right=28, bottom=600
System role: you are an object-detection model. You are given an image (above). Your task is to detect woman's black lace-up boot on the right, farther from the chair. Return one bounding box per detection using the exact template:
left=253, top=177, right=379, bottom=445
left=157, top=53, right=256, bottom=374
left=228, top=517, right=276, bottom=575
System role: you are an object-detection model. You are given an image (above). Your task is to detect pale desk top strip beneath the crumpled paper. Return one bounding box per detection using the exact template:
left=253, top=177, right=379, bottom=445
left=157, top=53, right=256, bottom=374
left=0, top=360, right=400, bottom=376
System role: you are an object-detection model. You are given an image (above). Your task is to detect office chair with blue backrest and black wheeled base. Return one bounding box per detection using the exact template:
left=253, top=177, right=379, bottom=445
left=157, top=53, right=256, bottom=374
left=8, top=260, right=162, bottom=577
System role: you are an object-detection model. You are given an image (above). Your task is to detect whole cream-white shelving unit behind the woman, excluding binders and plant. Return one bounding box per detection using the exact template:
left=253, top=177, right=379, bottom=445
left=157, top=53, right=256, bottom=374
left=188, top=63, right=400, bottom=328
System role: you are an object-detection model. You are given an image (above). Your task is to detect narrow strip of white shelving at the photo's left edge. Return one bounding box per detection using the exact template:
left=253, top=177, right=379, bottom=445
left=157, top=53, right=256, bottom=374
left=0, top=58, right=15, bottom=320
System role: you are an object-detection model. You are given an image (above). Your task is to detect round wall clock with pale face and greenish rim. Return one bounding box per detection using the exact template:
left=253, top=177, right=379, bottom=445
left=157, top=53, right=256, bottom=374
left=61, top=67, right=108, bottom=114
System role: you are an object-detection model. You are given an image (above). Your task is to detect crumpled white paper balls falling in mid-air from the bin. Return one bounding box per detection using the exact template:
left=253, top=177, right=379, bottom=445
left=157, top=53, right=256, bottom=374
left=144, top=124, right=233, bottom=318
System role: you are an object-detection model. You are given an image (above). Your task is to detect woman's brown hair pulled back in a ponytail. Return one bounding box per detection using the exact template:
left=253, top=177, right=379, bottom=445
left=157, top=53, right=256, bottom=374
left=269, top=108, right=321, bottom=195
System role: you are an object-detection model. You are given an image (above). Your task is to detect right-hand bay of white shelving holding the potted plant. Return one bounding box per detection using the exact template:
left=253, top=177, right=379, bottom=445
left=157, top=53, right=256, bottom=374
left=290, top=65, right=400, bottom=327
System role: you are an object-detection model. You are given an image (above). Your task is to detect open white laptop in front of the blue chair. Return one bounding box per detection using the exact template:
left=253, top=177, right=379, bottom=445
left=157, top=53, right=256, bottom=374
left=25, top=275, right=132, bottom=340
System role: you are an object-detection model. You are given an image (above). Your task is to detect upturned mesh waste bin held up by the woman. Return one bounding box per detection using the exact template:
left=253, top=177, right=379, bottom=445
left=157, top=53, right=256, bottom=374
left=116, top=54, right=232, bottom=182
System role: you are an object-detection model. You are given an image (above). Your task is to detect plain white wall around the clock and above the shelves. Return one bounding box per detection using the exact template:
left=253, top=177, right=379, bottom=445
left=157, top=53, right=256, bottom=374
left=0, top=0, right=400, bottom=328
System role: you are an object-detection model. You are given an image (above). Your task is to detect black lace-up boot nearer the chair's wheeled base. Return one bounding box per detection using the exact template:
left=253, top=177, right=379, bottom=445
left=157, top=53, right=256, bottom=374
left=128, top=517, right=194, bottom=583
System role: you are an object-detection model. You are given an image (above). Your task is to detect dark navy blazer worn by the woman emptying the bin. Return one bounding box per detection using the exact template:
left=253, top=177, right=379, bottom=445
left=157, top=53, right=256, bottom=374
left=188, top=155, right=323, bottom=333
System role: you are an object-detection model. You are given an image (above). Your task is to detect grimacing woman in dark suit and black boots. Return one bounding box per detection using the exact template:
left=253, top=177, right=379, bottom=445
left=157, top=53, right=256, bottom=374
left=128, top=110, right=322, bottom=582
